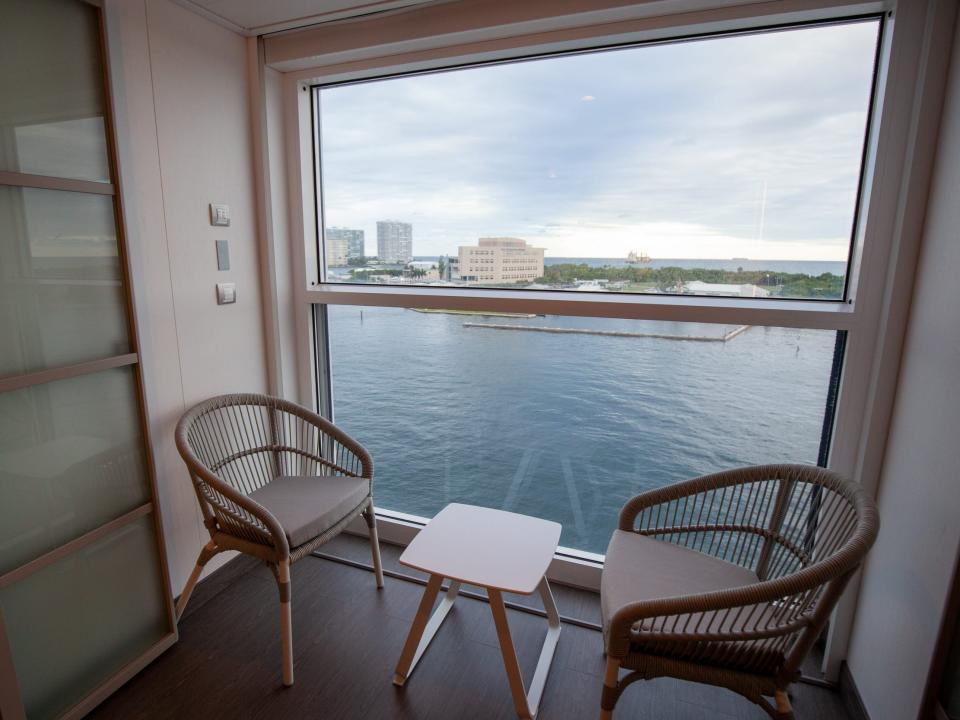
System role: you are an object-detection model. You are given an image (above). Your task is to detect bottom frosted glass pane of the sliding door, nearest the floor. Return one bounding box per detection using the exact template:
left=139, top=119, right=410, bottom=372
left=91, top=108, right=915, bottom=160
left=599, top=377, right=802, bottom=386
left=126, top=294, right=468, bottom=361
left=0, top=515, right=168, bottom=720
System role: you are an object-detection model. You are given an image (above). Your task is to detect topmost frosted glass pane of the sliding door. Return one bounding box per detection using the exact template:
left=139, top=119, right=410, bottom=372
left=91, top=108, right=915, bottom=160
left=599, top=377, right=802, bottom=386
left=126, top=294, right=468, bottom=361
left=0, top=0, right=110, bottom=181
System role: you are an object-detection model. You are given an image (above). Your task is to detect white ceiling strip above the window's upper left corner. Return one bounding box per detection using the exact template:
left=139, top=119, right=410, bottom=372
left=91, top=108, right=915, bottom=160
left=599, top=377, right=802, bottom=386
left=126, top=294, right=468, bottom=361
left=174, top=0, right=430, bottom=36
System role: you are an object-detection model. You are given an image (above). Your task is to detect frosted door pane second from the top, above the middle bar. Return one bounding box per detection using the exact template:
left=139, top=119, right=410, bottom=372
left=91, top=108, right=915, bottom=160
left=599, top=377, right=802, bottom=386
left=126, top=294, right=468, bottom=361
left=0, top=186, right=130, bottom=377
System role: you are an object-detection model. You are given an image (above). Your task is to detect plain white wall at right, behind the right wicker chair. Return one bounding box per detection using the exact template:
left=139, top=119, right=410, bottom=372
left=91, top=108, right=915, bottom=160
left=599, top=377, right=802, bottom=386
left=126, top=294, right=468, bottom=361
left=847, top=12, right=960, bottom=720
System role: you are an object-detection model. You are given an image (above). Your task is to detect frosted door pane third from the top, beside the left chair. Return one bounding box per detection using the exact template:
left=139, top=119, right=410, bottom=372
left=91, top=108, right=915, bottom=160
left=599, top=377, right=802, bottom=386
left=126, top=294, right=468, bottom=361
left=0, top=367, right=149, bottom=574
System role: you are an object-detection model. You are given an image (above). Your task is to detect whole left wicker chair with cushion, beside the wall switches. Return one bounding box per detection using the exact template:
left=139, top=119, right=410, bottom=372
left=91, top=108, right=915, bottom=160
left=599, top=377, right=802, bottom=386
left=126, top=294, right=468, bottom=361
left=176, top=395, right=383, bottom=686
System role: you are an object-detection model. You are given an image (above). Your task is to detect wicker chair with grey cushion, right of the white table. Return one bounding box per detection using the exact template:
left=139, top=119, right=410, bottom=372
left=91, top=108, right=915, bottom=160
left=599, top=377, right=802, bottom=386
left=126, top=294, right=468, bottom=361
left=600, top=465, right=879, bottom=720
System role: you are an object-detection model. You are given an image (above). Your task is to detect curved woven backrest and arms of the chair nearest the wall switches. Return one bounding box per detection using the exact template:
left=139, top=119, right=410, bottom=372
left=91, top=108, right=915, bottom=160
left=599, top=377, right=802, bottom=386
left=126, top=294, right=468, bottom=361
left=176, top=394, right=373, bottom=544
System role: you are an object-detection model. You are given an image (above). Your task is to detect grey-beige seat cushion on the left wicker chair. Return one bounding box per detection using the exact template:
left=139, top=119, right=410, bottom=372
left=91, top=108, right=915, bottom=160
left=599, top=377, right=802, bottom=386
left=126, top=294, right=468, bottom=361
left=250, top=475, right=370, bottom=548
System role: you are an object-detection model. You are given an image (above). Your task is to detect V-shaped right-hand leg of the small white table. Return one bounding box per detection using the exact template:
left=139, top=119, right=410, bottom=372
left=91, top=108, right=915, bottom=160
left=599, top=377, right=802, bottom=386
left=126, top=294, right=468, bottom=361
left=487, top=577, right=560, bottom=720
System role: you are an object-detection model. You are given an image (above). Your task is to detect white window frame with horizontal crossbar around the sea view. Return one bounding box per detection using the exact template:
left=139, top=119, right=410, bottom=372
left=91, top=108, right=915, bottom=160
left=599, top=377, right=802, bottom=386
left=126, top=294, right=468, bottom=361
left=270, top=0, right=945, bottom=679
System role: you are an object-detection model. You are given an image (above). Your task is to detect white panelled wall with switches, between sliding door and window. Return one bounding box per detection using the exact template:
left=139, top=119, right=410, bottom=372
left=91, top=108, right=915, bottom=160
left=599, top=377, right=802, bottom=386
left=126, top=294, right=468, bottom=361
left=106, top=0, right=267, bottom=594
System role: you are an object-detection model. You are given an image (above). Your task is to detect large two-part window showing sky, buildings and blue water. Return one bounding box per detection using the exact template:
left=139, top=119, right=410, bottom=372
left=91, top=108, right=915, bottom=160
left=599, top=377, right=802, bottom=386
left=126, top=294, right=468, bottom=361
left=308, top=17, right=882, bottom=553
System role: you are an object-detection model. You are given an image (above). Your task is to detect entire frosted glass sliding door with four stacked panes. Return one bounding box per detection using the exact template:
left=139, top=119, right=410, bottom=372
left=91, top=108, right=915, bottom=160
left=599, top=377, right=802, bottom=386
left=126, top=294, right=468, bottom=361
left=0, top=0, right=176, bottom=720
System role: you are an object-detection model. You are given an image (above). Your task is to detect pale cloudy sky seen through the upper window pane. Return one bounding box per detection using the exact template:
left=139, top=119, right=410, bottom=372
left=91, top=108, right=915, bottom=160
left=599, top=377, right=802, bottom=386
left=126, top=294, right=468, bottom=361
left=320, top=21, right=878, bottom=260
